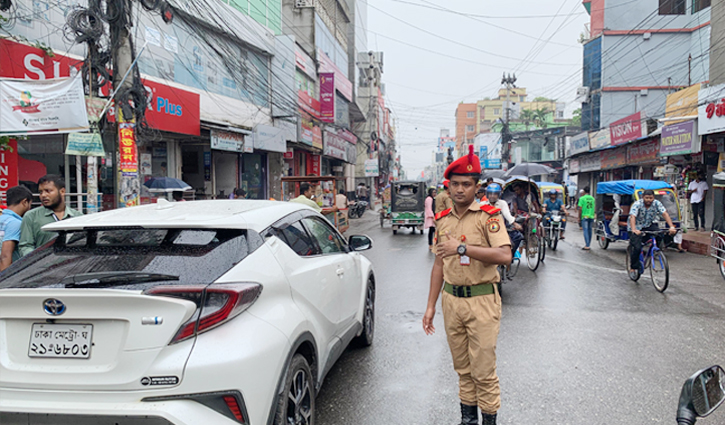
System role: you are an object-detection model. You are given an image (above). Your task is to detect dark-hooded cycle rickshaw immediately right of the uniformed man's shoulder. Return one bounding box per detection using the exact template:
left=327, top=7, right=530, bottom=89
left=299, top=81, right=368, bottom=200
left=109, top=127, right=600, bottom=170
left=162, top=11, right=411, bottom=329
left=502, top=177, right=546, bottom=271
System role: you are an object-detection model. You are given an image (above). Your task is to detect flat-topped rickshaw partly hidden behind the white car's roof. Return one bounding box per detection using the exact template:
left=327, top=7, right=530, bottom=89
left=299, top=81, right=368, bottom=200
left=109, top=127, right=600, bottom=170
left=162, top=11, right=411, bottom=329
left=282, top=176, right=350, bottom=233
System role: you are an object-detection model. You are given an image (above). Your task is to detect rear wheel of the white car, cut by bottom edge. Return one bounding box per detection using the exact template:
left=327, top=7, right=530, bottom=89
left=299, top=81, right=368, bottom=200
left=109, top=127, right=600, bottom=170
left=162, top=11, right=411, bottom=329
left=274, top=354, right=315, bottom=425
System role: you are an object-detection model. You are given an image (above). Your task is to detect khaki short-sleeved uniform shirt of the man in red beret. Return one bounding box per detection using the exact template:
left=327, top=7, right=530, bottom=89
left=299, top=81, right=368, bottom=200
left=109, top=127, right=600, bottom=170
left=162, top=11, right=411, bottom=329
left=436, top=202, right=511, bottom=286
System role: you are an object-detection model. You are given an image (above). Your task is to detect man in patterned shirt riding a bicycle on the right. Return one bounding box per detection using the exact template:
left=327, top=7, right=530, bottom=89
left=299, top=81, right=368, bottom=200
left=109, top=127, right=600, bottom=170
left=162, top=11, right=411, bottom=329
left=627, top=189, right=677, bottom=273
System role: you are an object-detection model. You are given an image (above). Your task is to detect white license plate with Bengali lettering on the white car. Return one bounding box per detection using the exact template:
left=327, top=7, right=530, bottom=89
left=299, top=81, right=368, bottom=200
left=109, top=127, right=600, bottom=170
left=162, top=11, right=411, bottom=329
left=28, top=323, right=93, bottom=359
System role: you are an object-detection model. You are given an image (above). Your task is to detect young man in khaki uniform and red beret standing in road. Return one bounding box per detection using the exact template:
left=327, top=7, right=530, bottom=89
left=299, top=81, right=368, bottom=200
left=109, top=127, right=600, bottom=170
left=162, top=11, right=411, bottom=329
left=423, top=148, right=511, bottom=425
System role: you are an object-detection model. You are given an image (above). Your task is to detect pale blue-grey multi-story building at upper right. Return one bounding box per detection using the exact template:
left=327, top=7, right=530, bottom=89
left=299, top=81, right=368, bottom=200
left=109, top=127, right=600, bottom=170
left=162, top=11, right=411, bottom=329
left=582, top=0, right=710, bottom=130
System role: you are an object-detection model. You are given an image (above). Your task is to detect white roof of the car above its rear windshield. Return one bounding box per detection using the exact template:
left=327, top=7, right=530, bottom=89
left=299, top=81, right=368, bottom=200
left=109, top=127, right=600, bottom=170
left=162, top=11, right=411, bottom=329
left=43, top=199, right=314, bottom=232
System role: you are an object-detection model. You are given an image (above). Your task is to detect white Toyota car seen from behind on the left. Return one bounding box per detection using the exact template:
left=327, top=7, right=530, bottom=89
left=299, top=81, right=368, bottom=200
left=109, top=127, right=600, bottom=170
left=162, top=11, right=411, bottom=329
left=0, top=200, right=375, bottom=425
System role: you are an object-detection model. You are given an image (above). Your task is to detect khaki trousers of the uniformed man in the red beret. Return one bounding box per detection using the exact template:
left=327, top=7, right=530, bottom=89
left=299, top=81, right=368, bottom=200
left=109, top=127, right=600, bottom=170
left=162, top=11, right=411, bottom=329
left=441, top=284, right=501, bottom=414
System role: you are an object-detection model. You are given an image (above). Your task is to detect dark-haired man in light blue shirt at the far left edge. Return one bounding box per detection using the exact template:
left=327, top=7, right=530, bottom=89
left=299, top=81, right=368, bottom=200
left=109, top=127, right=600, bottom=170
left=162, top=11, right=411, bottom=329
left=0, top=186, right=33, bottom=271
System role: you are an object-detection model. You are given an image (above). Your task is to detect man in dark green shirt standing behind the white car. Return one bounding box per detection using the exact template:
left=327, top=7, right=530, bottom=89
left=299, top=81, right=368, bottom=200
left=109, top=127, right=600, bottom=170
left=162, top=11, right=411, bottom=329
left=18, top=174, right=83, bottom=256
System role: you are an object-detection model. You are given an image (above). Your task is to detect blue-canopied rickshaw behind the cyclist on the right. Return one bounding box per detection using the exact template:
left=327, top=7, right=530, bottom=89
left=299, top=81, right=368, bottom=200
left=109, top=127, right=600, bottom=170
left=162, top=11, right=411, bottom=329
left=594, top=180, right=682, bottom=249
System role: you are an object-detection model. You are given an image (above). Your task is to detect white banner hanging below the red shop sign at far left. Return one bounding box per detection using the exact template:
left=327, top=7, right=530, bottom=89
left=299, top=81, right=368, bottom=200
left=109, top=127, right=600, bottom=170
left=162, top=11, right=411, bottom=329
left=0, top=74, right=89, bottom=135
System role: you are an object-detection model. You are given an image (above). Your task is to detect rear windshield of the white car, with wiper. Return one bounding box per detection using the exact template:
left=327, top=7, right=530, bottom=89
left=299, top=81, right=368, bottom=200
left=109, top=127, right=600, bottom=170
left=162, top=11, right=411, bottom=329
left=0, top=228, right=263, bottom=290
